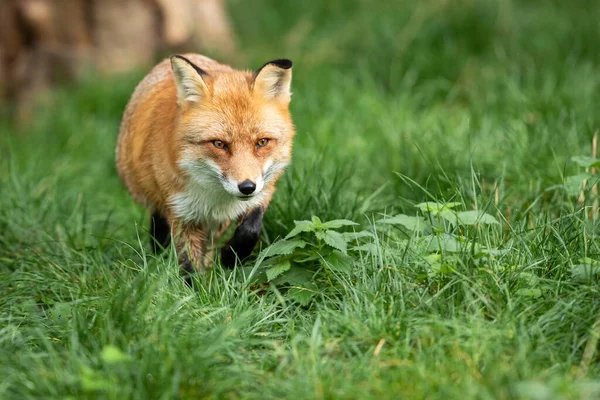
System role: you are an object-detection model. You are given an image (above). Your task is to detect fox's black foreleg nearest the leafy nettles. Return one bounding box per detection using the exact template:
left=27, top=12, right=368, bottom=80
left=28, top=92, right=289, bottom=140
left=221, top=207, right=264, bottom=268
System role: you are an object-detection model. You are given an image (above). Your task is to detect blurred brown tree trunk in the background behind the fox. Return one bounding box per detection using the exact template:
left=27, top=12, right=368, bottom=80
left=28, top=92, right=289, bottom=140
left=0, top=0, right=235, bottom=119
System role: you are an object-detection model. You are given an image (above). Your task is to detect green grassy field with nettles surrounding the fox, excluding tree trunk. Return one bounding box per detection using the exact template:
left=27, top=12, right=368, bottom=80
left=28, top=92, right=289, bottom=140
left=0, top=0, right=600, bottom=399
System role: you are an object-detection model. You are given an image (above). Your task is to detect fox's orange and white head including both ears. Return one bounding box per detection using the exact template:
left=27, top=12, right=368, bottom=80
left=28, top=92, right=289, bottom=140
left=171, top=56, right=294, bottom=200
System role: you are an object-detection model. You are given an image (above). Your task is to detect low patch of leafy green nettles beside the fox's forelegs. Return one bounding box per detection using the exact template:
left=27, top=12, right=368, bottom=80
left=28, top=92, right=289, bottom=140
left=256, top=202, right=502, bottom=305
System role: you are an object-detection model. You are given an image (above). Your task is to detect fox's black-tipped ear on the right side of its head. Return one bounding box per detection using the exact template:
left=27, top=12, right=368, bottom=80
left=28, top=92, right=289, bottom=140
left=253, top=59, right=292, bottom=102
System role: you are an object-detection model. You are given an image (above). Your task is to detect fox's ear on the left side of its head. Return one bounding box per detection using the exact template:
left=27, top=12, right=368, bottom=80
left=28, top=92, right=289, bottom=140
left=171, top=55, right=208, bottom=105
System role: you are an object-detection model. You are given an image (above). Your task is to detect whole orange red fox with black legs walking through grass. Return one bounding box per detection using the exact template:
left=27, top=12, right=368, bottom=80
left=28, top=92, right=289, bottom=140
left=116, top=54, right=295, bottom=273
